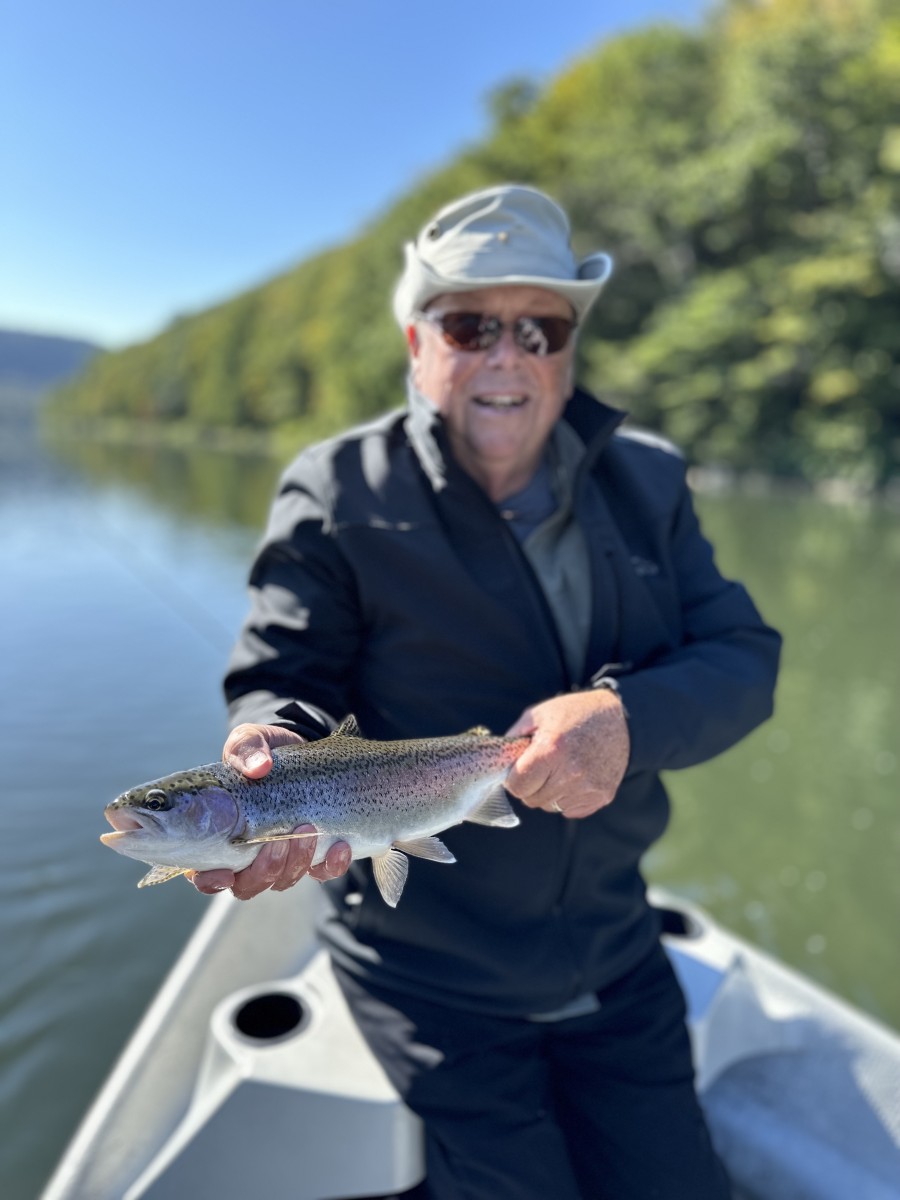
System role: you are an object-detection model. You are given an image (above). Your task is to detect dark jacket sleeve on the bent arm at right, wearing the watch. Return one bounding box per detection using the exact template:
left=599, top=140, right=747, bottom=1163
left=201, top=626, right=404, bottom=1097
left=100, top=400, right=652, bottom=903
left=618, top=472, right=781, bottom=774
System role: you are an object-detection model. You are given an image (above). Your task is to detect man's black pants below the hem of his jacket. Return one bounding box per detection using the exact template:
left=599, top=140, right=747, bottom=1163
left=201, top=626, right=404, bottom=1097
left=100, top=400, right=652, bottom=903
left=335, top=947, right=731, bottom=1200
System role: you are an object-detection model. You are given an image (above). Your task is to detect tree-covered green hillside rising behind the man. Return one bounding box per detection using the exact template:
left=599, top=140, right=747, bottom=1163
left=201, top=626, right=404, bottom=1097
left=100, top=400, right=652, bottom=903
left=45, top=0, right=900, bottom=486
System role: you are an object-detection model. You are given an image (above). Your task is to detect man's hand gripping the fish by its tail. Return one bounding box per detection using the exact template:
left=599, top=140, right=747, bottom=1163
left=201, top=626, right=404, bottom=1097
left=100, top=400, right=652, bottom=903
left=505, top=688, right=631, bottom=817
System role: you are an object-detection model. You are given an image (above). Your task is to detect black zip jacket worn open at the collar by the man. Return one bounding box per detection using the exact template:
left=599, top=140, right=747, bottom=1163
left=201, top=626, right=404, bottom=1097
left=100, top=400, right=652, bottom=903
left=226, top=392, right=780, bottom=1013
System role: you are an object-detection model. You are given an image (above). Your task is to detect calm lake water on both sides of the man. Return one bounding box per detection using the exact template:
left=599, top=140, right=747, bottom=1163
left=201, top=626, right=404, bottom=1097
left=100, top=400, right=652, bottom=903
left=0, top=434, right=900, bottom=1200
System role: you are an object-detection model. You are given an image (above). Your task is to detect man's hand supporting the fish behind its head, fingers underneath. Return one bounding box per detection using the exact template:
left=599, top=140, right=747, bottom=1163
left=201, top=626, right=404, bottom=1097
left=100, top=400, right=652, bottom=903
left=187, top=725, right=350, bottom=900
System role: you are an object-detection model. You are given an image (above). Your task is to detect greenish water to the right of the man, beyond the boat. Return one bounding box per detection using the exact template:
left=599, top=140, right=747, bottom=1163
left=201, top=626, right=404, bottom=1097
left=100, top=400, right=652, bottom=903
left=649, top=497, right=900, bottom=1026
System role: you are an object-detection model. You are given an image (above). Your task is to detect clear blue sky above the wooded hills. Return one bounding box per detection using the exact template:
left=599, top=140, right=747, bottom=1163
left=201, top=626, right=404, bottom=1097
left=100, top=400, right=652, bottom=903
left=0, top=0, right=708, bottom=348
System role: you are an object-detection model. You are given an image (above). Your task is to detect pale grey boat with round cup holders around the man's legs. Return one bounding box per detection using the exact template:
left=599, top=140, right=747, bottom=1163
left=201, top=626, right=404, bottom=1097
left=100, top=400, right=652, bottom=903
left=42, top=881, right=900, bottom=1200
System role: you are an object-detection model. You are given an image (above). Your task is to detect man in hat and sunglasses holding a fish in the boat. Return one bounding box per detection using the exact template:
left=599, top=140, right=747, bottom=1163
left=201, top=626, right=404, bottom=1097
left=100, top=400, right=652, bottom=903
left=194, top=185, right=779, bottom=1200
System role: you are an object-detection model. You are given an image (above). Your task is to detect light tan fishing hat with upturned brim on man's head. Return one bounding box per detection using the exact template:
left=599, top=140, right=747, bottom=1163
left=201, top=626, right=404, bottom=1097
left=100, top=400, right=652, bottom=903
left=394, top=184, right=612, bottom=329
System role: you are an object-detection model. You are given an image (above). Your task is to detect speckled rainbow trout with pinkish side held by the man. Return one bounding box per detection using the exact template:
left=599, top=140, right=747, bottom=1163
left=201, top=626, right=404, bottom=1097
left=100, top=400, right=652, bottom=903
left=100, top=715, right=530, bottom=908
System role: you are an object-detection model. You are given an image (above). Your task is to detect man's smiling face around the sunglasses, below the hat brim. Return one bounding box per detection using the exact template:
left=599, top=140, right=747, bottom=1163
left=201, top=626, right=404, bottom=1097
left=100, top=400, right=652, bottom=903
left=407, top=286, right=575, bottom=500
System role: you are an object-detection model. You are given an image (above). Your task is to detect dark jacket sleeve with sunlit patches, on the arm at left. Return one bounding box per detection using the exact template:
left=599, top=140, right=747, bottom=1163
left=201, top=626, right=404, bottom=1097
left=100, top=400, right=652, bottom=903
left=224, top=456, right=361, bottom=738
